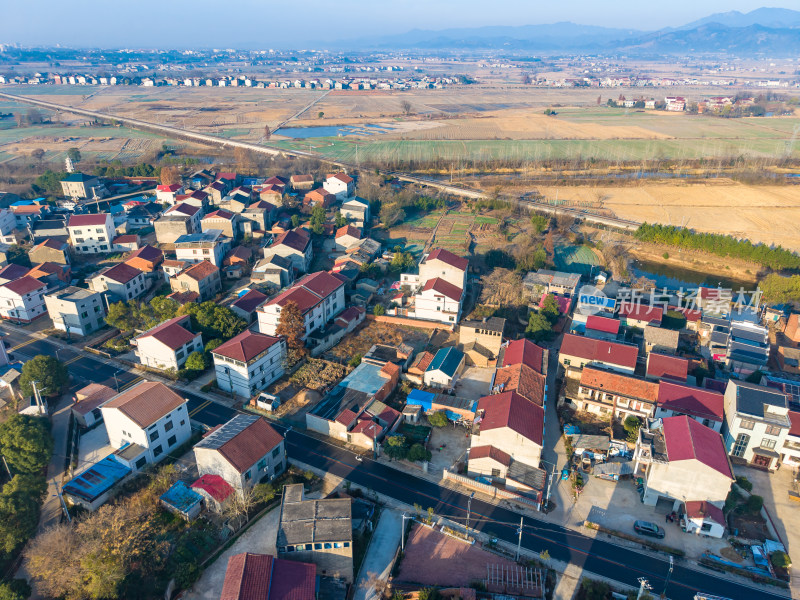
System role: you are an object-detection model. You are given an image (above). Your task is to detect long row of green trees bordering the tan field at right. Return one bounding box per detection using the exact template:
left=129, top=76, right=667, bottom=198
left=635, top=223, right=800, bottom=271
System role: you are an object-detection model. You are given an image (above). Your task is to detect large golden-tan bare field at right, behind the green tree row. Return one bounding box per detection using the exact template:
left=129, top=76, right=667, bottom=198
left=539, top=181, right=800, bottom=251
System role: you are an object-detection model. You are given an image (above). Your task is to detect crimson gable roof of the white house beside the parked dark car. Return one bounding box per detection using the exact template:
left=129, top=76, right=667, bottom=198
left=661, top=416, right=733, bottom=480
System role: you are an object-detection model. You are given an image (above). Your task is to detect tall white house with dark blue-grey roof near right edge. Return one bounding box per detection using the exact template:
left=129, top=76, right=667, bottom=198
left=722, top=379, right=791, bottom=470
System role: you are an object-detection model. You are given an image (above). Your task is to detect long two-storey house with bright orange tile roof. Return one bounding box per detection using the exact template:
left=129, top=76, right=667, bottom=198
left=567, top=367, right=658, bottom=422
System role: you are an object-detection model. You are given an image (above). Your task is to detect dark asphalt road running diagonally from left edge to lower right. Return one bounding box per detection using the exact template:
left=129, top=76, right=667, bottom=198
left=3, top=328, right=787, bottom=600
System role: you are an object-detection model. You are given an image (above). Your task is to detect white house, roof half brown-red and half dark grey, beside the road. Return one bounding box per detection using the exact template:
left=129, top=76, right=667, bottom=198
left=194, top=414, right=287, bottom=494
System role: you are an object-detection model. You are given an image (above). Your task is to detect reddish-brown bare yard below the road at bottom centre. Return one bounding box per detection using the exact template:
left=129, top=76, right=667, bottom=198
left=395, top=524, right=515, bottom=587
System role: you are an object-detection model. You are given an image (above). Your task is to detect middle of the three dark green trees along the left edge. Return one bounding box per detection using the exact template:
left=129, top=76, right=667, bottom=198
left=0, top=413, right=53, bottom=473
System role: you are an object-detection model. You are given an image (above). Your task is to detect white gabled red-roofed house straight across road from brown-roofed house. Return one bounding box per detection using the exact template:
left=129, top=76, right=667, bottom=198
left=131, top=315, right=203, bottom=371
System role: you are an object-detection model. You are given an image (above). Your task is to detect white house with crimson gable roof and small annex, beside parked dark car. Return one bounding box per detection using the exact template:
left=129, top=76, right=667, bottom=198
left=634, top=416, right=734, bottom=538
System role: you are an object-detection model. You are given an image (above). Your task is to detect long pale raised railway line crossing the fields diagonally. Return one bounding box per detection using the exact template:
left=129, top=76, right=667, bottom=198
left=0, top=92, right=640, bottom=231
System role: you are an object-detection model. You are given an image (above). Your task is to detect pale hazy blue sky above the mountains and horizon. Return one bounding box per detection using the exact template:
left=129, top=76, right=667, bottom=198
left=0, top=0, right=800, bottom=48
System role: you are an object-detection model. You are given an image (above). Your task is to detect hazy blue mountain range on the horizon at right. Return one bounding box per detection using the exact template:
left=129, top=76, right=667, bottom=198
left=341, top=8, right=800, bottom=56
